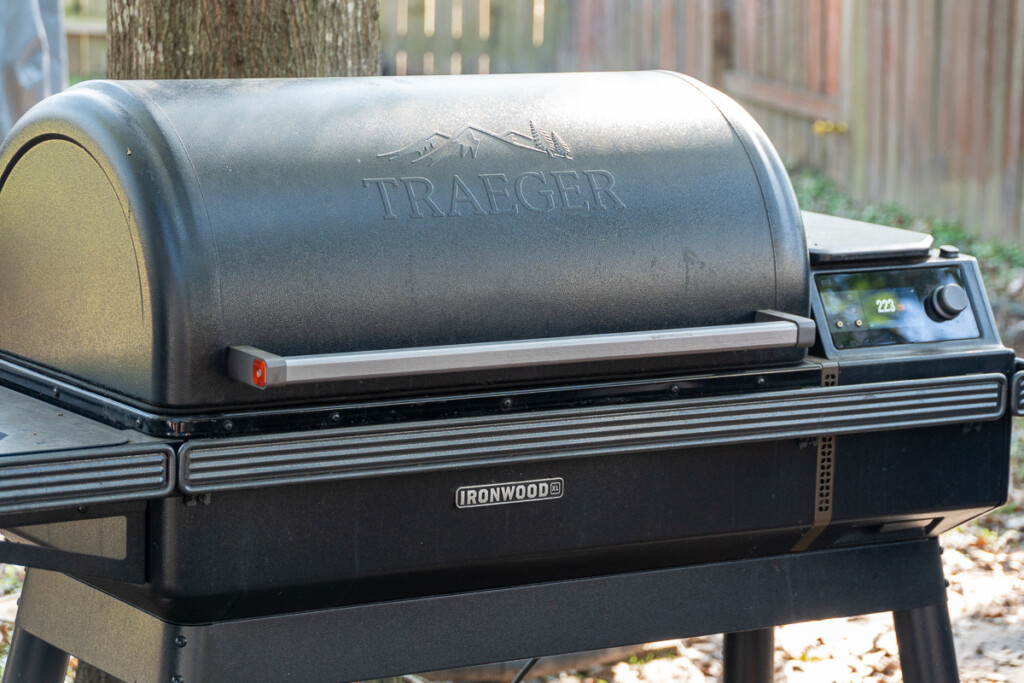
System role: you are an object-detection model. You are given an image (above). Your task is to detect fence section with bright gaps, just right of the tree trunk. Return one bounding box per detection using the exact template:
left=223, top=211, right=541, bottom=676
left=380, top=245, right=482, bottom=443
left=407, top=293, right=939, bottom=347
left=381, top=0, right=716, bottom=80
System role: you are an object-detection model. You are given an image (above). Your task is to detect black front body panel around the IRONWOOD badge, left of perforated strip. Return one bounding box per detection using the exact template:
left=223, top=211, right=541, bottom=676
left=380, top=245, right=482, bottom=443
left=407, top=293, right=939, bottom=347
left=83, top=439, right=819, bottom=623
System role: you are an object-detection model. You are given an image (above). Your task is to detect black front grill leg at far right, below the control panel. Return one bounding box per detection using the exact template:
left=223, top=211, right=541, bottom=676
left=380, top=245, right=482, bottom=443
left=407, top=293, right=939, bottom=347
left=893, top=602, right=959, bottom=683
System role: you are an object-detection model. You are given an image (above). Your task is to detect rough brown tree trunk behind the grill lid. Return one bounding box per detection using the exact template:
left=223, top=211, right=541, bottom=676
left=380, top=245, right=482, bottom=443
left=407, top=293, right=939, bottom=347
left=106, top=0, right=380, bottom=79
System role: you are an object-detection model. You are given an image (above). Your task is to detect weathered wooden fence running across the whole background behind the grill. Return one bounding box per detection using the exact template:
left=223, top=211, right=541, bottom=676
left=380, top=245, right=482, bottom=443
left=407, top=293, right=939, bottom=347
left=69, top=0, right=1024, bottom=244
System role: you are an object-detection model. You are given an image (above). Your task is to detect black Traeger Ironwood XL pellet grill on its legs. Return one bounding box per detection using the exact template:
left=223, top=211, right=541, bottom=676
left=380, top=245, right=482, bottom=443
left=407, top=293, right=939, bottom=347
left=0, top=73, right=1020, bottom=683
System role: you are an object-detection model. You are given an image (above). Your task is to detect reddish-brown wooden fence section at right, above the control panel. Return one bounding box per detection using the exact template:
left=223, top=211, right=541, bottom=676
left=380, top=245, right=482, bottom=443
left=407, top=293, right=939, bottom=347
left=724, top=0, right=1024, bottom=243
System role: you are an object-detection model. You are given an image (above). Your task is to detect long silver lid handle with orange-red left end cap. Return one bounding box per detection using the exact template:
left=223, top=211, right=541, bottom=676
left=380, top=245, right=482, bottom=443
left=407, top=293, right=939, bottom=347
left=227, top=310, right=815, bottom=389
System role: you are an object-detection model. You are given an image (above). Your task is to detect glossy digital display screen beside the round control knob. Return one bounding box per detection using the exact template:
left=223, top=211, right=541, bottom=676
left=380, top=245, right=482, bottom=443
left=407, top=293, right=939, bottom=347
left=815, top=266, right=980, bottom=349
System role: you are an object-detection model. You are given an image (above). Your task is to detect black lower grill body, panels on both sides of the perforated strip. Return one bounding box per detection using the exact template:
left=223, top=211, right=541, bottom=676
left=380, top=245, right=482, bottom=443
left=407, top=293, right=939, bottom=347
left=22, top=415, right=991, bottom=623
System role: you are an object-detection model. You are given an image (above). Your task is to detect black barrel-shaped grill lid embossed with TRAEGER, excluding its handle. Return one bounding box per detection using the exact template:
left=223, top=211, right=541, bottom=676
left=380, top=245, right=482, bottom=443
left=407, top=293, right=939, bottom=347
left=0, top=72, right=808, bottom=410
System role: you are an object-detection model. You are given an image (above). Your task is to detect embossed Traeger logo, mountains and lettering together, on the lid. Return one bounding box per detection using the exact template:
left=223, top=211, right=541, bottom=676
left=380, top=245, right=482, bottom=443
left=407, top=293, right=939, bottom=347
left=362, top=121, right=626, bottom=220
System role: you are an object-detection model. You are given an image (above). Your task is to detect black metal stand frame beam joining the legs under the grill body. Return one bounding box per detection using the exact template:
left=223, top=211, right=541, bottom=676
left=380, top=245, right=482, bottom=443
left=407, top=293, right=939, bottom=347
left=12, top=540, right=945, bottom=683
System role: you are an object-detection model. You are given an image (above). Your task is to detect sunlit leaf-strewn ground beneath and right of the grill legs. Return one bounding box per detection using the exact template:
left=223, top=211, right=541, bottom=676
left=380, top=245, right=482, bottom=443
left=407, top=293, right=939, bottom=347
left=549, top=471, right=1024, bottom=683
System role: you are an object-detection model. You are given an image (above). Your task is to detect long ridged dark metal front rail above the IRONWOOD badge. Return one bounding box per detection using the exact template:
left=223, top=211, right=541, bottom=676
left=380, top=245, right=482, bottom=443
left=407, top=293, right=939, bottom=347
left=181, top=374, right=1007, bottom=493
